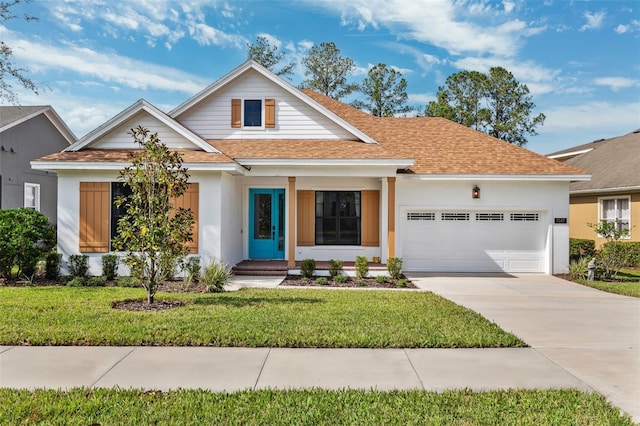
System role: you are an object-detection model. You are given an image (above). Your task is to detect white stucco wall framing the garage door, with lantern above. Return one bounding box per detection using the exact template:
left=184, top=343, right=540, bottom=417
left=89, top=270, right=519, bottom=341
left=396, top=176, right=569, bottom=274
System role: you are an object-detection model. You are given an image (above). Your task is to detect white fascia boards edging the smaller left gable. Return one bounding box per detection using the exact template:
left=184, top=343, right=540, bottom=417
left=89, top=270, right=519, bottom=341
left=64, top=99, right=220, bottom=153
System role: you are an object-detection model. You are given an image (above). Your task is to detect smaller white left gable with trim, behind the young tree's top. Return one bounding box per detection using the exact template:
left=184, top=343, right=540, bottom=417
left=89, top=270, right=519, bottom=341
left=65, top=99, right=218, bottom=152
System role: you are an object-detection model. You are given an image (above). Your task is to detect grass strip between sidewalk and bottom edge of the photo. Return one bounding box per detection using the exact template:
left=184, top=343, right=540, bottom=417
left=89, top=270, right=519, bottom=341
left=0, top=389, right=633, bottom=425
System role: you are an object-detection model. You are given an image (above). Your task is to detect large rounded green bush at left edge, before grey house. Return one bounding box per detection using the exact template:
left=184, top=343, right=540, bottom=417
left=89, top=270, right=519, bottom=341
left=0, top=208, right=56, bottom=278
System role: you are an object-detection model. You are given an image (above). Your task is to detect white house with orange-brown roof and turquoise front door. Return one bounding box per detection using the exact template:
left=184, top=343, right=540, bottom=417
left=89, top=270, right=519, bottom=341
left=32, top=61, right=588, bottom=273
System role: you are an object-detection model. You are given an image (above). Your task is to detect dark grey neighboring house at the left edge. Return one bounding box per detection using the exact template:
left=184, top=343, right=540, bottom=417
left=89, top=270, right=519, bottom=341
left=0, top=106, right=76, bottom=224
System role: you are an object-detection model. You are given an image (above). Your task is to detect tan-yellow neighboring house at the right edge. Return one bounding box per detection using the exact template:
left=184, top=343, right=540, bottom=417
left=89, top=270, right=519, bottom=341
left=549, top=129, right=640, bottom=246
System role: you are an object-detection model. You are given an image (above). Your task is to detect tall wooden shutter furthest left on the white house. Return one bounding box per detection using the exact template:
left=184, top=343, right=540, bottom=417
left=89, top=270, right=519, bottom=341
left=78, top=182, right=111, bottom=253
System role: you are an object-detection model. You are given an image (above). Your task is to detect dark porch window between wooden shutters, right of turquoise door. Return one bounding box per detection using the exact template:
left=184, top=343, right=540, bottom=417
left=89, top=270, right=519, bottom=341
left=316, top=191, right=361, bottom=245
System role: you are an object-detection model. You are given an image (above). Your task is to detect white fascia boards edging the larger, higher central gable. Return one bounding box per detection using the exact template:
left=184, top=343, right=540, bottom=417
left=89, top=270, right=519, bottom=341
left=169, top=60, right=378, bottom=144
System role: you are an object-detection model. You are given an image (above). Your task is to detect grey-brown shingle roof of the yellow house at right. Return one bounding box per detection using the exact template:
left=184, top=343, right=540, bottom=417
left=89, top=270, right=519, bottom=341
left=566, top=131, right=640, bottom=191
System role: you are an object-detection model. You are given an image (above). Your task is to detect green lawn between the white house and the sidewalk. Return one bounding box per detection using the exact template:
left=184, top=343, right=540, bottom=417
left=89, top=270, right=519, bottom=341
left=0, top=287, right=525, bottom=348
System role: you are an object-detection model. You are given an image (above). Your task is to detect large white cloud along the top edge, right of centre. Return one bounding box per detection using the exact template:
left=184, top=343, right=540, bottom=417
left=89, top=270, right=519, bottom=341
left=321, top=0, right=528, bottom=56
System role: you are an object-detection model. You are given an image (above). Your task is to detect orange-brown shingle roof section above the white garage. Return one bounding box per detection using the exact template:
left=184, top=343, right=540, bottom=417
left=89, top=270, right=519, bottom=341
left=304, top=90, right=585, bottom=175
